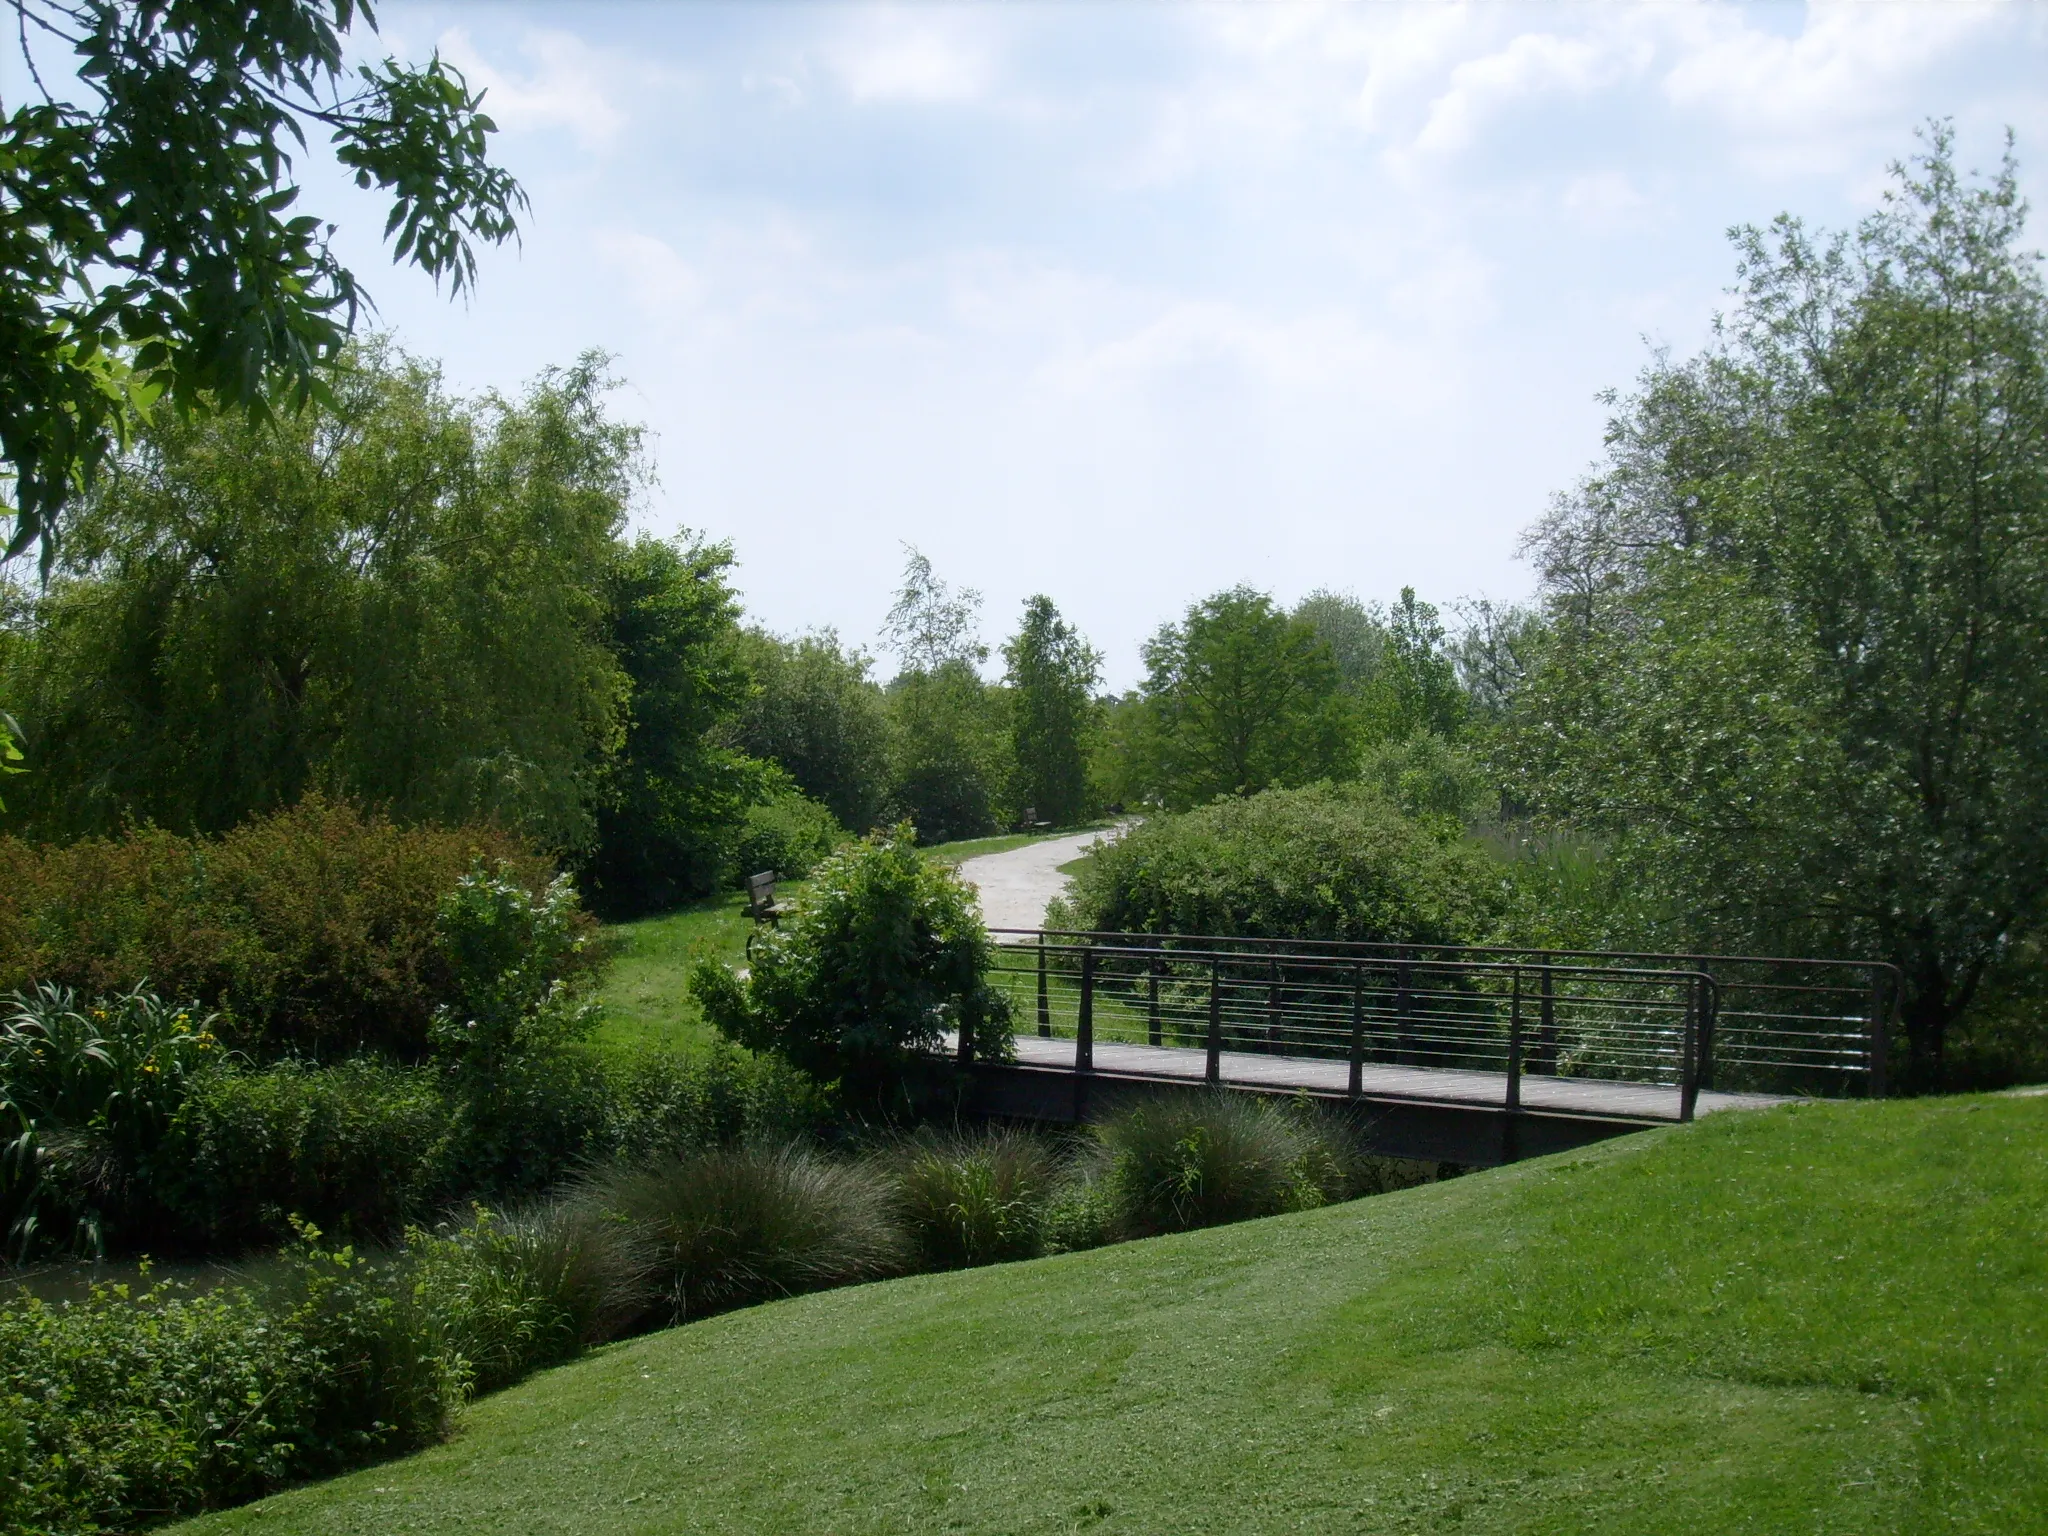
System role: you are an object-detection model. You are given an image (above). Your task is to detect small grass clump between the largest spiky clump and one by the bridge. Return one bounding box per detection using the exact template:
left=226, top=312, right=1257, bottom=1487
left=881, top=1128, right=1061, bottom=1270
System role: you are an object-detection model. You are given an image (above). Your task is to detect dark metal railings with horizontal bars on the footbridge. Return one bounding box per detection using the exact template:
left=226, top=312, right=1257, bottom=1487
left=966, top=930, right=1898, bottom=1118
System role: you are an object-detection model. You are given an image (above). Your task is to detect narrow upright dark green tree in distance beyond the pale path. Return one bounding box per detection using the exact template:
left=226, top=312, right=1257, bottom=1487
left=1004, top=594, right=1102, bottom=827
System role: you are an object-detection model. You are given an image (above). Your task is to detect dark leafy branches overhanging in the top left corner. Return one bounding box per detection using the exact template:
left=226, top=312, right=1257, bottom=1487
left=0, top=0, right=526, bottom=567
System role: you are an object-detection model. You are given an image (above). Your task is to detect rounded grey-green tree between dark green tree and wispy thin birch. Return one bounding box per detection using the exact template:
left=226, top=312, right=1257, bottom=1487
left=733, top=629, right=889, bottom=831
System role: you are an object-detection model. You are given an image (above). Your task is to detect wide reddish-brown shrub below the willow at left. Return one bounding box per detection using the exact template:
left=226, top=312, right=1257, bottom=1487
left=0, top=797, right=577, bottom=1059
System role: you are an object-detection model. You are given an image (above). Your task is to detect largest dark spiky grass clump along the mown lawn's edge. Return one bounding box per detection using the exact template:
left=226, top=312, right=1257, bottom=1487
left=586, top=1147, right=905, bottom=1319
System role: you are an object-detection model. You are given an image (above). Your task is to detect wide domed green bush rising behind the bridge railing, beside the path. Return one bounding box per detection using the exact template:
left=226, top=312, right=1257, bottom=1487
left=1049, top=784, right=1501, bottom=944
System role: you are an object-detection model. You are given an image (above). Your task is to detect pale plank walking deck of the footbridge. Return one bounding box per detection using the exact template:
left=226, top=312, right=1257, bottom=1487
left=987, top=1034, right=1788, bottom=1122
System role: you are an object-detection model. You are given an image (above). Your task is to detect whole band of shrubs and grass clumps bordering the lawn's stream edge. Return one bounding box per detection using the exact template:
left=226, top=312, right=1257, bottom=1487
left=0, top=1094, right=1432, bottom=1532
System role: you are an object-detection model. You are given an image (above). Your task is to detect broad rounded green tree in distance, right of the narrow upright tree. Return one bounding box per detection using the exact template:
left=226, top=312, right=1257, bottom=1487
left=1139, top=586, right=1350, bottom=809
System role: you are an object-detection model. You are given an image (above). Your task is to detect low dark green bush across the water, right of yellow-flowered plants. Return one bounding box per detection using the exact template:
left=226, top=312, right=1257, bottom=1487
left=158, top=1059, right=457, bottom=1251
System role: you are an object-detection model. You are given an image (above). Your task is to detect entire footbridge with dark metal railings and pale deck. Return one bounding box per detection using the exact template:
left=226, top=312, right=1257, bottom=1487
left=954, top=928, right=1898, bottom=1163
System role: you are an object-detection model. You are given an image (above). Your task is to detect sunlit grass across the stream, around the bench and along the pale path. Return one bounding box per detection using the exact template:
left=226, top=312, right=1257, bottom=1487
left=596, top=827, right=1075, bottom=1051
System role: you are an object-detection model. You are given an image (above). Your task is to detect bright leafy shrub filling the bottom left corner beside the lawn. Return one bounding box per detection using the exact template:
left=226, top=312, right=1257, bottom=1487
left=0, top=1229, right=465, bottom=1532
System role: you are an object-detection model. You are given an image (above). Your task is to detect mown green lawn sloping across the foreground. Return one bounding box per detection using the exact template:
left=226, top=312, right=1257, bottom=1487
left=180, top=1098, right=2048, bottom=1536
